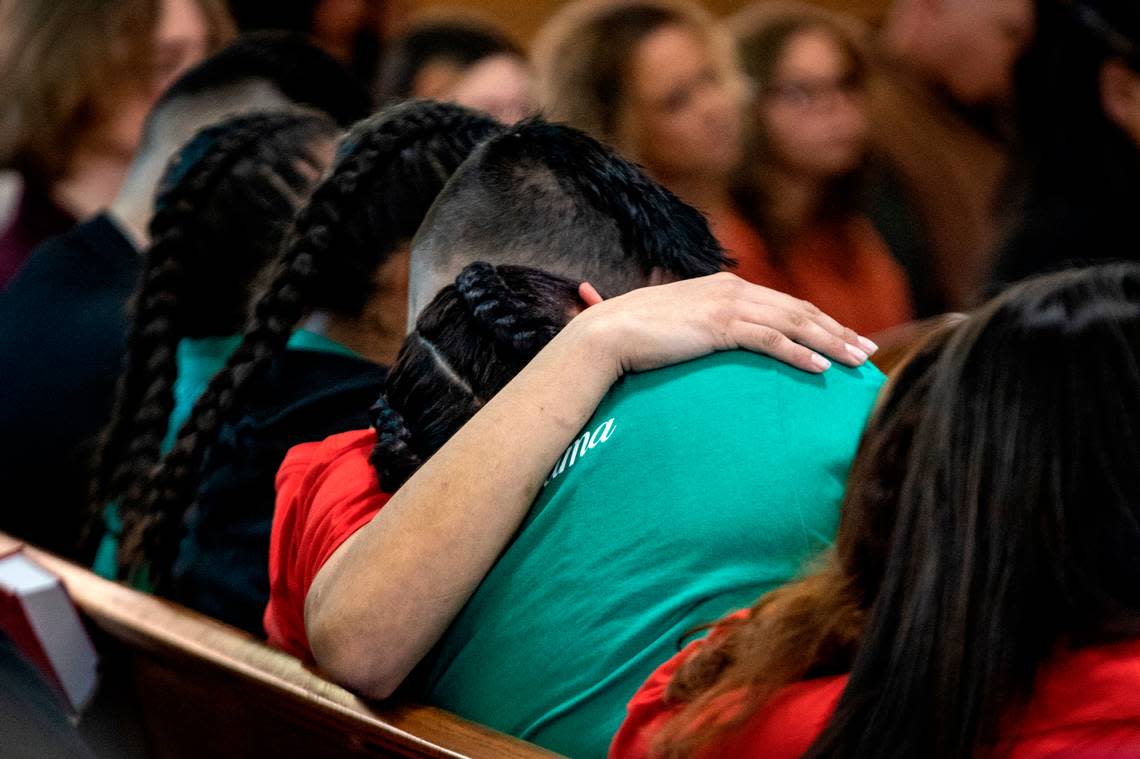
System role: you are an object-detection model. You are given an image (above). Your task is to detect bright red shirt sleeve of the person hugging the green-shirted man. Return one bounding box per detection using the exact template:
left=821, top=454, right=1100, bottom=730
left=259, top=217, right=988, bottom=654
left=264, top=430, right=391, bottom=661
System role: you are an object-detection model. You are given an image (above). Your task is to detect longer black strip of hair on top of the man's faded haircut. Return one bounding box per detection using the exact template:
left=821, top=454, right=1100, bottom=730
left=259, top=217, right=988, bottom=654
left=487, top=117, right=734, bottom=278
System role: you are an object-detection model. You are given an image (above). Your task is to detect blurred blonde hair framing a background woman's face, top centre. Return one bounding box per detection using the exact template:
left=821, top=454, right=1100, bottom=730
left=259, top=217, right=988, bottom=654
left=531, top=0, right=744, bottom=153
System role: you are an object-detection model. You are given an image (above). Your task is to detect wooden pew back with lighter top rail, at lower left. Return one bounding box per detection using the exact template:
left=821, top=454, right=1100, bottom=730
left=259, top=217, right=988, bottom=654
left=0, top=533, right=556, bottom=759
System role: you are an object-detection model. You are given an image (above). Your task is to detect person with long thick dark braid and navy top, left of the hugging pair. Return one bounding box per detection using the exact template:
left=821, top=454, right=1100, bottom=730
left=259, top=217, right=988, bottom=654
left=114, top=101, right=499, bottom=634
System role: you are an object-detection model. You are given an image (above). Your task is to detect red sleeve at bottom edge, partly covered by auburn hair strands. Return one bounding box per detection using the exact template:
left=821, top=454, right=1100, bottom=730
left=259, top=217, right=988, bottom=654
left=610, top=611, right=847, bottom=759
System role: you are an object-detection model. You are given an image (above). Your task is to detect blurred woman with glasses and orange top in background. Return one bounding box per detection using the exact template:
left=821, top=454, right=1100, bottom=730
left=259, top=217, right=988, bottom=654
left=733, top=2, right=913, bottom=334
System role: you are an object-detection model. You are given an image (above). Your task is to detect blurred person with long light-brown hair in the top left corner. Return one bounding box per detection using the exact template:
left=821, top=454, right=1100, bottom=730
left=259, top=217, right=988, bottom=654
left=0, top=0, right=233, bottom=289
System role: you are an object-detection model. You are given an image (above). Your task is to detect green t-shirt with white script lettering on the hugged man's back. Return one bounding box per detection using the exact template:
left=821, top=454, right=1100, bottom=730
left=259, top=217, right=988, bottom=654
left=421, top=351, right=884, bottom=757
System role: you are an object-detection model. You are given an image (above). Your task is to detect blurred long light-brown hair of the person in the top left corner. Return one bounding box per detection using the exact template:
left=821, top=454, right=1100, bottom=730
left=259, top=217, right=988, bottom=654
left=0, top=0, right=234, bottom=181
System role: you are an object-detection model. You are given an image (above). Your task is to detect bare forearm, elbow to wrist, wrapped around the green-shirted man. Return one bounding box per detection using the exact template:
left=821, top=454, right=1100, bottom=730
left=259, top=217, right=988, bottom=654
left=306, top=323, right=618, bottom=697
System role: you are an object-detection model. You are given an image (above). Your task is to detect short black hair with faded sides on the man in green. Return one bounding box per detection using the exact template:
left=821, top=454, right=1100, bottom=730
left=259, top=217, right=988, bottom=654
left=413, top=119, right=730, bottom=295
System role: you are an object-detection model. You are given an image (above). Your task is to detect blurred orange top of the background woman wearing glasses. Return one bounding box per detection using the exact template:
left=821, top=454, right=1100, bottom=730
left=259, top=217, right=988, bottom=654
left=713, top=213, right=914, bottom=335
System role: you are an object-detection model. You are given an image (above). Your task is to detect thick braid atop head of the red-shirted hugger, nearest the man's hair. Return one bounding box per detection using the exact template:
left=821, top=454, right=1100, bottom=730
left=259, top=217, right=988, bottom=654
left=455, top=261, right=562, bottom=356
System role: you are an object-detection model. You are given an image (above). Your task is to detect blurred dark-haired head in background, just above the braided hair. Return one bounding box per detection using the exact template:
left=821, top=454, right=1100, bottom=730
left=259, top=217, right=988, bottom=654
left=377, top=14, right=536, bottom=124
